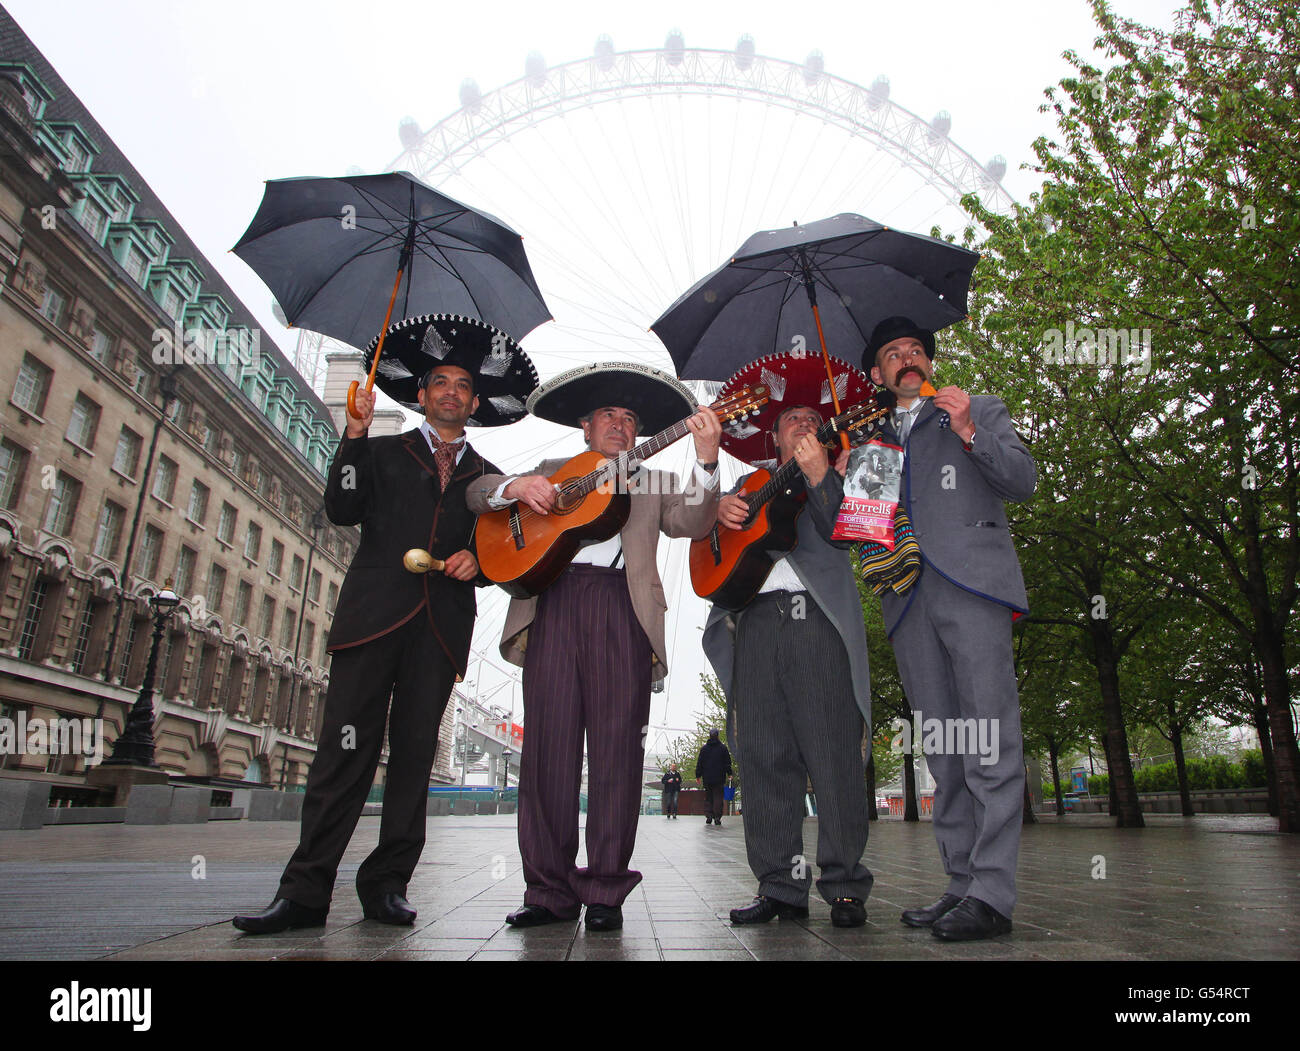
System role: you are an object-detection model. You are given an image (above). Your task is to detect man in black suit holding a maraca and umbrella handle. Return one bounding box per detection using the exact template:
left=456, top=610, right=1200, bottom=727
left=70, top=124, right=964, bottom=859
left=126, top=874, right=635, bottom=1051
left=233, top=348, right=512, bottom=934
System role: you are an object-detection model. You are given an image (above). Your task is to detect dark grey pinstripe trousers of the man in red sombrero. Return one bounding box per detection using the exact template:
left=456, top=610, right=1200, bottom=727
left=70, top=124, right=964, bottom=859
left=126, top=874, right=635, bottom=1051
left=732, top=592, right=872, bottom=905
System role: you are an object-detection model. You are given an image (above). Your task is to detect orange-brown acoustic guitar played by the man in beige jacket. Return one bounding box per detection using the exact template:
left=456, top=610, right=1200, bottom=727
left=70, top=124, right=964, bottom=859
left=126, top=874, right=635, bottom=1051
left=476, top=384, right=767, bottom=598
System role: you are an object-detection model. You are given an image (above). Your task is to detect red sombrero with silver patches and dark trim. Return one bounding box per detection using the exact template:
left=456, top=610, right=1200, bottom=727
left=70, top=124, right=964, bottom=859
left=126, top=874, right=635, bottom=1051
left=718, top=350, right=876, bottom=467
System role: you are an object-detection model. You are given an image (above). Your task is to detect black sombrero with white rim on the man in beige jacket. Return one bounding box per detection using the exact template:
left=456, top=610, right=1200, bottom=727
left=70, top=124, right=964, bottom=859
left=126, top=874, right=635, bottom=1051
left=528, top=362, right=699, bottom=434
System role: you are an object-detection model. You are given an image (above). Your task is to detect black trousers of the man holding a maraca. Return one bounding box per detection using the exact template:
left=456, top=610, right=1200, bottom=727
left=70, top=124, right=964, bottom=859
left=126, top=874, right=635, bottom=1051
left=278, top=610, right=456, bottom=908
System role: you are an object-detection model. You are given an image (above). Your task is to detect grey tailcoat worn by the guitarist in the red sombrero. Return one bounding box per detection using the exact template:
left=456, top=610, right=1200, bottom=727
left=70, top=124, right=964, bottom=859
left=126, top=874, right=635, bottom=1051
left=703, top=471, right=871, bottom=741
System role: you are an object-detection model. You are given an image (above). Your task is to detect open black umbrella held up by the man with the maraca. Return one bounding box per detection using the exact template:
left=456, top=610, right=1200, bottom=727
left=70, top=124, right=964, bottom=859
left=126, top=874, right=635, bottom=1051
left=233, top=172, right=551, bottom=415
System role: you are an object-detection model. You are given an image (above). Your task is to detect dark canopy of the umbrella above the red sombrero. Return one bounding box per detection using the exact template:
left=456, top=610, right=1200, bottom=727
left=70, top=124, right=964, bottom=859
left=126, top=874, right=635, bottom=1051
left=650, top=213, right=979, bottom=380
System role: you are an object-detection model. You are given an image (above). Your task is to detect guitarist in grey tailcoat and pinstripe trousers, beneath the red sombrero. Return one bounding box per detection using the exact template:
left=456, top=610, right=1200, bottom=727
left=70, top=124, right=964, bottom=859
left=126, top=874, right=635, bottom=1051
left=703, top=400, right=872, bottom=927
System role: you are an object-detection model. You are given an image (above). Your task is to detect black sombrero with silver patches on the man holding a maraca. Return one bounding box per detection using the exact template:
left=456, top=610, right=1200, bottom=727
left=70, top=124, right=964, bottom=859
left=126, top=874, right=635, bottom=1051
left=365, top=313, right=537, bottom=427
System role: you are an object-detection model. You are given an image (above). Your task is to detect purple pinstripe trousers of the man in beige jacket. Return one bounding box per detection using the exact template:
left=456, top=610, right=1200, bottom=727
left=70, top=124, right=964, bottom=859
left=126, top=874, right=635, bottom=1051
left=519, top=565, right=653, bottom=918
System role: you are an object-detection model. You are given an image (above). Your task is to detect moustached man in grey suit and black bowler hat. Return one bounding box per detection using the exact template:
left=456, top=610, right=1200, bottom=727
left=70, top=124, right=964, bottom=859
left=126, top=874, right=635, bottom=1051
left=852, top=317, right=1037, bottom=942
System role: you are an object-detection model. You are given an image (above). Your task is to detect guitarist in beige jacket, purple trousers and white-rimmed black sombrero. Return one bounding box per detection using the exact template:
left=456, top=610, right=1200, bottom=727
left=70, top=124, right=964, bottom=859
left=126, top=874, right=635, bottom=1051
left=468, top=363, right=722, bottom=930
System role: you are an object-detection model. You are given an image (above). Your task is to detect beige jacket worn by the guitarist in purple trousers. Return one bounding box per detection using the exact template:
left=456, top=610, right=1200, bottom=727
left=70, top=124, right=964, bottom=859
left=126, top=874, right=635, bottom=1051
left=468, top=459, right=718, bottom=680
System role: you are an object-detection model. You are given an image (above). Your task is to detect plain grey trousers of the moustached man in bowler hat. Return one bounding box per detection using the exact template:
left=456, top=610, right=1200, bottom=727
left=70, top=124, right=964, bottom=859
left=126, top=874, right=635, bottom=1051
left=892, top=566, right=1024, bottom=916
